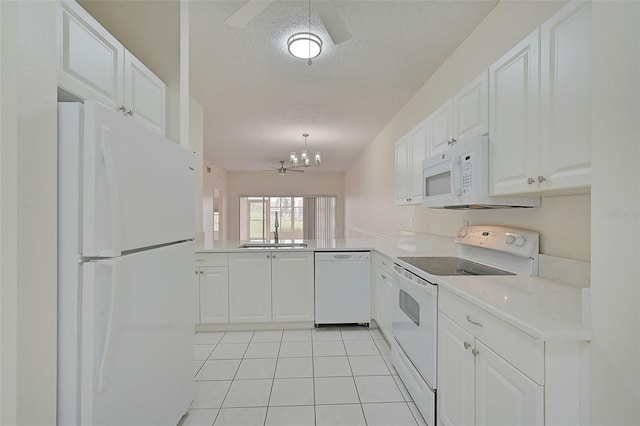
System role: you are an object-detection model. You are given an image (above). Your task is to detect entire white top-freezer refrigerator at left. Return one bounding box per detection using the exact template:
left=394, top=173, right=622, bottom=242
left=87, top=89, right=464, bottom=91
left=57, top=101, right=195, bottom=426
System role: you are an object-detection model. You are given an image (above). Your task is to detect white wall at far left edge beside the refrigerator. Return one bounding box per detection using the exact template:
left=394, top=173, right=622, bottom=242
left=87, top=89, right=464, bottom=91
left=0, top=1, right=57, bottom=425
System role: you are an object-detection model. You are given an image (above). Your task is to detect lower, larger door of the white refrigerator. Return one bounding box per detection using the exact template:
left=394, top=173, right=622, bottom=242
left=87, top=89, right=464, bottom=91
left=78, top=242, right=195, bottom=426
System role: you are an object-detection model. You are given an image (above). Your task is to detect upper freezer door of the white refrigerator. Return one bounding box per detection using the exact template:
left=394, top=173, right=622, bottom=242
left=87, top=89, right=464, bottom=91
left=80, top=101, right=195, bottom=257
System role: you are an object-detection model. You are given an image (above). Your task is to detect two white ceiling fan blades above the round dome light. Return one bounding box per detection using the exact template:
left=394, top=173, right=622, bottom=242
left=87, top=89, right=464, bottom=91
left=224, top=0, right=351, bottom=44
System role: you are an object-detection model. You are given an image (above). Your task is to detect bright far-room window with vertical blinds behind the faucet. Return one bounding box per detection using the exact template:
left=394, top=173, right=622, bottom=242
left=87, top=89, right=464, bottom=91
left=239, top=196, right=336, bottom=241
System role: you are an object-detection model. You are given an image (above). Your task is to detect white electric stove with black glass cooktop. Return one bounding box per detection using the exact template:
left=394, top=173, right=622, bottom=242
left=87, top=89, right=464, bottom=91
left=391, top=225, right=539, bottom=425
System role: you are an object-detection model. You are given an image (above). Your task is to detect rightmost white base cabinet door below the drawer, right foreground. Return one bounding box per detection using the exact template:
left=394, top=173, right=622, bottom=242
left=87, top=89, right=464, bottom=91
left=472, top=341, right=544, bottom=426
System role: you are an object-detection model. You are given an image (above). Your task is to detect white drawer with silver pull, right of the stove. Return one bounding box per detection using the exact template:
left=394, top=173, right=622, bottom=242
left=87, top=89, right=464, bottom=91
left=438, top=287, right=544, bottom=385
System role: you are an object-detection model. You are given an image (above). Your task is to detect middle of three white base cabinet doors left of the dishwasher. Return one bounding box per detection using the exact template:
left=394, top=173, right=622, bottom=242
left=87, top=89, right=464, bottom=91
left=229, top=252, right=271, bottom=323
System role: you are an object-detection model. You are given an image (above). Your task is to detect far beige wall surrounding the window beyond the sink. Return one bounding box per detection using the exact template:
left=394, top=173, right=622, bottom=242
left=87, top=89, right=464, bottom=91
left=227, top=172, right=344, bottom=240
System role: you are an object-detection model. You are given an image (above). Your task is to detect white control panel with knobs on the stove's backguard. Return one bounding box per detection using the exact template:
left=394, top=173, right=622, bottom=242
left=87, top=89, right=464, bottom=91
left=456, top=225, right=539, bottom=257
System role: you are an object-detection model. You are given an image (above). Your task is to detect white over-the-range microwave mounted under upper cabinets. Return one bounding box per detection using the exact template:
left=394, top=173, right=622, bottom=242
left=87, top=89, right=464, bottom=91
left=422, top=136, right=540, bottom=209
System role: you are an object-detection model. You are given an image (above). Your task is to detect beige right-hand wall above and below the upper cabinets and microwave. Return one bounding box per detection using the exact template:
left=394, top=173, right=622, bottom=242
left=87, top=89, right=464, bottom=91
left=345, top=1, right=590, bottom=261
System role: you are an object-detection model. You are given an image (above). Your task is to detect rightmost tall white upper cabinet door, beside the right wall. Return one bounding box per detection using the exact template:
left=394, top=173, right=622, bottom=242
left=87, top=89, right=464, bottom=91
left=539, top=2, right=591, bottom=190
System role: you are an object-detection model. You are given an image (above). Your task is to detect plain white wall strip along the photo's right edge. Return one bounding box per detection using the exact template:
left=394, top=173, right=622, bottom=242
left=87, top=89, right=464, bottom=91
left=591, top=1, right=640, bottom=425
